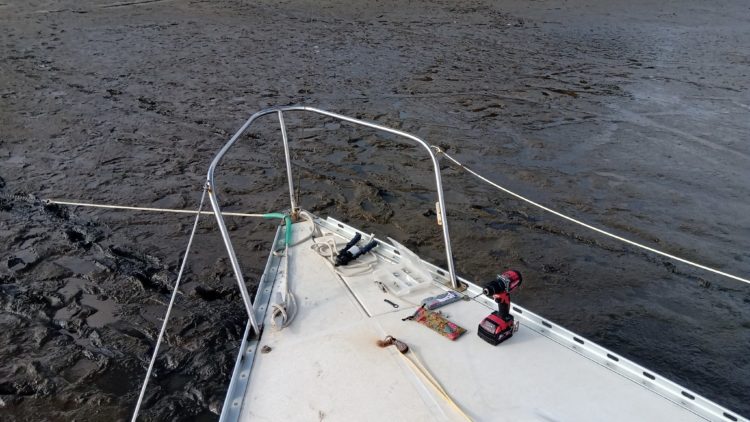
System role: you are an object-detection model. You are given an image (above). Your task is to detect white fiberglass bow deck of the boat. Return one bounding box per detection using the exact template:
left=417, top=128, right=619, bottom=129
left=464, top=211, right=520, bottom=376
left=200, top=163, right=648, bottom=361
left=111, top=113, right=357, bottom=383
left=222, top=219, right=742, bottom=421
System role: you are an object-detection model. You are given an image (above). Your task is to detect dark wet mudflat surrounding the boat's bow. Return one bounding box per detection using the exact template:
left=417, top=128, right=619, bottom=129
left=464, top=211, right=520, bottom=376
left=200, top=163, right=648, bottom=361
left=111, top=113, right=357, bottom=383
left=0, top=0, right=750, bottom=420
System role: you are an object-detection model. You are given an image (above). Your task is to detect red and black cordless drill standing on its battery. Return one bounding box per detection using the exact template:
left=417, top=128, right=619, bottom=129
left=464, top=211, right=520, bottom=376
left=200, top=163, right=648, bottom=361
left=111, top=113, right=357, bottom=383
left=477, top=270, right=523, bottom=345
